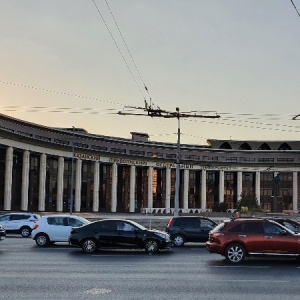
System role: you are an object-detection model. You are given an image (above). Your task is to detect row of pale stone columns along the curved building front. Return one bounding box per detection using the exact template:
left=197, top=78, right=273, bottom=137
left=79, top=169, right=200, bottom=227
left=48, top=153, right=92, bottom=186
left=3, top=147, right=298, bottom=212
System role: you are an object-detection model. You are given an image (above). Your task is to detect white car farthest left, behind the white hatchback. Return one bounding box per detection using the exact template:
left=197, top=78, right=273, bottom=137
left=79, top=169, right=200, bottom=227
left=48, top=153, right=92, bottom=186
left=0, top=213, right=41, bottom=237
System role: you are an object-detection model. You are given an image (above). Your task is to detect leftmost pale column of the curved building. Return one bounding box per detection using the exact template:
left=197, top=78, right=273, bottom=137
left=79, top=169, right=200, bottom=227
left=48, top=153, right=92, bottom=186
left=3, top=147, right=14, bottom=210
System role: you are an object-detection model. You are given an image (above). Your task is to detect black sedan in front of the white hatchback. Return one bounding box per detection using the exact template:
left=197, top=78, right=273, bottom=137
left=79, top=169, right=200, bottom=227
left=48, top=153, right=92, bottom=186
left=69, top=219, right=172, bottom=254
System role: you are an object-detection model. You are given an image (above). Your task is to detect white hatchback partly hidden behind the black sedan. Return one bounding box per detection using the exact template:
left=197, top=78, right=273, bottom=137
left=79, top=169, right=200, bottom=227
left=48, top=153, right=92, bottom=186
left=31, top=215, right=91, bottom=247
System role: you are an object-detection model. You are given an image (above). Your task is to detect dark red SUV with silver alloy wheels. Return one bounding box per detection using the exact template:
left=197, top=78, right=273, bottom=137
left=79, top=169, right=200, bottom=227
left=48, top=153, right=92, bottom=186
left=206, top=219, right=300, bottom=263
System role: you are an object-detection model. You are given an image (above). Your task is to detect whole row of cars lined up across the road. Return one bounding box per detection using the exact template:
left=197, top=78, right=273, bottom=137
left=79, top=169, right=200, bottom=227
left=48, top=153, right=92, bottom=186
left=0, top=213, right=300, bottom=263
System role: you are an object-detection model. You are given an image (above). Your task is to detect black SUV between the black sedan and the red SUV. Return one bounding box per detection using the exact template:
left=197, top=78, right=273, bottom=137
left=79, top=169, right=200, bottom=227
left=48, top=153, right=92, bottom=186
left=166, top=216, right=218, bottom=247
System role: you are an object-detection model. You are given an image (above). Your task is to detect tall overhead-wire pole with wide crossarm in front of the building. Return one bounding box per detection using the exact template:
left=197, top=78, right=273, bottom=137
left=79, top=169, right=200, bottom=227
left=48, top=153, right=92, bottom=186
left=118, top=103, right=220, bottom=216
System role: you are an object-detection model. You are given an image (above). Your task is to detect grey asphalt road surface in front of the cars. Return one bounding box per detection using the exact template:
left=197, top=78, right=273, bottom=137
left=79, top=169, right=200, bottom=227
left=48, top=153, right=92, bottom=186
left=0, top=235, right=300, bottom=300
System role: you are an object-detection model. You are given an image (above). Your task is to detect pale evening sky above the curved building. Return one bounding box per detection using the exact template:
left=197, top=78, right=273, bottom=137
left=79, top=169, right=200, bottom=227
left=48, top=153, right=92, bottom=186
left=0, top=0, right=300, bottom=144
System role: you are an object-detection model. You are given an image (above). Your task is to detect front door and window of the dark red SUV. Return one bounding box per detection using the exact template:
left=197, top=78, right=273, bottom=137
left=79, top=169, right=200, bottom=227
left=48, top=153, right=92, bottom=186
left=263, top=222, right=300, bottom=254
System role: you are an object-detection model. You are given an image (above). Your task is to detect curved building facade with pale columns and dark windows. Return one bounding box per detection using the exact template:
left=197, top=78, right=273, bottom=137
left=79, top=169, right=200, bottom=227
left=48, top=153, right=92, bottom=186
left=0, top=114, right=300, bottom=212
